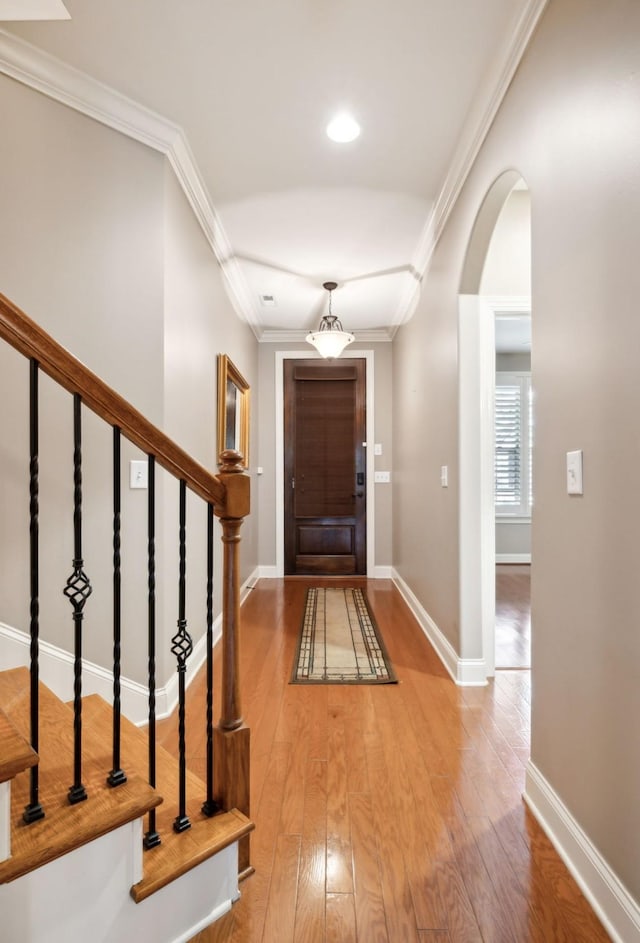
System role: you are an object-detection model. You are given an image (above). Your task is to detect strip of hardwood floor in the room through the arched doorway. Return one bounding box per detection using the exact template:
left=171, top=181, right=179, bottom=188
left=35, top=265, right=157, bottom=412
left=496, top=563, right=531, bottom=668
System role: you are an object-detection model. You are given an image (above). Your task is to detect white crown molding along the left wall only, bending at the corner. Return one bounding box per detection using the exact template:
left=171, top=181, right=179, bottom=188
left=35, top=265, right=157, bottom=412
left=0, top=30, right=260, bottom=336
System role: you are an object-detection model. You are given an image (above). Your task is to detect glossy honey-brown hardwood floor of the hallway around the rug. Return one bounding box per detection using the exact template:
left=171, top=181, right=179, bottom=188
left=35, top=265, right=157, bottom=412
left=164, top=579, right=609, bottom=943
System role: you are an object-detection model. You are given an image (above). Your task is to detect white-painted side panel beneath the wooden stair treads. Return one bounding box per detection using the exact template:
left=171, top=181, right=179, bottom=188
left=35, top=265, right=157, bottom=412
left=0, top=818, right=240, bottom=943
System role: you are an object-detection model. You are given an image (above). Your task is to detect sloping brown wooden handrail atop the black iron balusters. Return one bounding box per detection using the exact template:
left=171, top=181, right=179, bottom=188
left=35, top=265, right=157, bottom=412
left=0, top=294, right=230, bottom=516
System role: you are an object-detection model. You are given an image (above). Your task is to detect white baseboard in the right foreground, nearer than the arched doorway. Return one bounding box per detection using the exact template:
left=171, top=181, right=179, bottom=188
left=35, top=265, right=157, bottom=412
left=524, top=761, right=640, bottom=943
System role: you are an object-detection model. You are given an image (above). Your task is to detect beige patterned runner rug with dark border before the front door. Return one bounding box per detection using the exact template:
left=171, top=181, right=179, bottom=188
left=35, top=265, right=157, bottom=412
left=291, top=587, right=397, bottom=684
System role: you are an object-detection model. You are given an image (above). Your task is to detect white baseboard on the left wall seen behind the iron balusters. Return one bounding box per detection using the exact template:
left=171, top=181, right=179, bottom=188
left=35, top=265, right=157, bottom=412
left=0, top=569, right=258, bottom=726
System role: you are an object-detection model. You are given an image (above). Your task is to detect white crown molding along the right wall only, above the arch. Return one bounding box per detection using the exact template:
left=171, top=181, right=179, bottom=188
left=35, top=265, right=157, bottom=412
left=392, top=0, right=549, bottom=334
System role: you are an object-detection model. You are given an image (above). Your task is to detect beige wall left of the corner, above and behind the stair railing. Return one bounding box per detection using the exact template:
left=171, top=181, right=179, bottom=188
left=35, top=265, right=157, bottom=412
left=0, top=77, right=168, bottom=677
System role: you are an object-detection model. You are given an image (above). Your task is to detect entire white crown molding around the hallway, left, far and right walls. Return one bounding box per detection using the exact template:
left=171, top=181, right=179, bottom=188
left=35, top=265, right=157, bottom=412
left=0, top=0, right=548, bottom=342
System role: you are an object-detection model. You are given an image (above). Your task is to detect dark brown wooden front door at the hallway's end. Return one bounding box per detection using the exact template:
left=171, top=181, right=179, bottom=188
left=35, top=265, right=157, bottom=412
left=284, top=359, right=367, bottom=575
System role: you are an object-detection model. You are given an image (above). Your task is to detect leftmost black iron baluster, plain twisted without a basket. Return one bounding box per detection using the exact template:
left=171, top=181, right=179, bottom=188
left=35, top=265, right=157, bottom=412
left=22, top=359, right=44, bottom=823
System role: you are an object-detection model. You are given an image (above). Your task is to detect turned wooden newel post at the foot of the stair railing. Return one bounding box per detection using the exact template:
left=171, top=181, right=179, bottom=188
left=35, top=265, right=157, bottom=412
left=213, top=449, right=253, bottom=877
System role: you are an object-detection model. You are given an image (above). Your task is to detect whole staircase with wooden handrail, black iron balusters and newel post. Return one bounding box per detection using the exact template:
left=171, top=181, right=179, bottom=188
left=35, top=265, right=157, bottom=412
left=0, top=295, right=253, bottom=943
